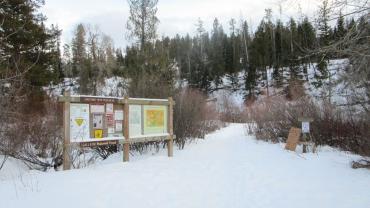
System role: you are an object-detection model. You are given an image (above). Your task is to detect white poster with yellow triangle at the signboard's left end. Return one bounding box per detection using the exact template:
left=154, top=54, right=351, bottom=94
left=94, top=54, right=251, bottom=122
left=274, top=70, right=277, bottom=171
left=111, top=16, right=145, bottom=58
left=69, top=103, right=90, bottom=142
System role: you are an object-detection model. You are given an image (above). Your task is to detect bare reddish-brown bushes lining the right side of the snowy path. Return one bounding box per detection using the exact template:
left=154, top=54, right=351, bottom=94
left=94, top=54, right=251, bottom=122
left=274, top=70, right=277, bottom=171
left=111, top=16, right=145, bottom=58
left=249, top=97, right=370, bottom=155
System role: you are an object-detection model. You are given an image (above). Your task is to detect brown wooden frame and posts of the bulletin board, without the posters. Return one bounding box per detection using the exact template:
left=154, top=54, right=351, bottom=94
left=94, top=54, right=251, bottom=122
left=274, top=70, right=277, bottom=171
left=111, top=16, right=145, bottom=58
left=58, top=91, right=176, bottom=170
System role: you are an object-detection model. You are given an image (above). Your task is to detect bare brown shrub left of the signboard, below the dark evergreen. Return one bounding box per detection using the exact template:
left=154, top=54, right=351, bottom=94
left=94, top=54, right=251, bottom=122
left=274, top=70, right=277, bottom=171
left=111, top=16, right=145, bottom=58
left=0, top=99, right=63, bottom=171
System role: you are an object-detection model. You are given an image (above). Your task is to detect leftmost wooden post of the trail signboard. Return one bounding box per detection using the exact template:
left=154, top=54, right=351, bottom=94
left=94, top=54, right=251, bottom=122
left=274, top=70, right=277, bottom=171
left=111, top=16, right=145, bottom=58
left=63, top=91, right=71, bottom=170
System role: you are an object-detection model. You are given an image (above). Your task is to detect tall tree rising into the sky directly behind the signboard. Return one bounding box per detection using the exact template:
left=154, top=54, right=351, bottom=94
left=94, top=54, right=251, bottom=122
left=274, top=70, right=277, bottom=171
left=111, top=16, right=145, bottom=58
left=126, top=0, right=176, bottom=97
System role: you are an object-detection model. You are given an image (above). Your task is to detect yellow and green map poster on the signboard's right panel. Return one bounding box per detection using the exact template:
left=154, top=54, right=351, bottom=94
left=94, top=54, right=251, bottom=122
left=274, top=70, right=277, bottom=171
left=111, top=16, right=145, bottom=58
left=144, top=105, right=167, bottom=134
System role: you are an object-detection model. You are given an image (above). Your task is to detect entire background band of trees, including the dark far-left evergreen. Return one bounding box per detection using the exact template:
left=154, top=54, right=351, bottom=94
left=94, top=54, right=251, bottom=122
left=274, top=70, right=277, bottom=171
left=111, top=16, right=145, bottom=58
left=0, top=0, right=368, bottom=111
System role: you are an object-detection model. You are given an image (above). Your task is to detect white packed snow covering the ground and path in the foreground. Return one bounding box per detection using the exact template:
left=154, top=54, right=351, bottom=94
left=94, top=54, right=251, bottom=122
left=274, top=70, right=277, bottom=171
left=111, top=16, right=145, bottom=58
left=0, top=124, right=370, bottom=208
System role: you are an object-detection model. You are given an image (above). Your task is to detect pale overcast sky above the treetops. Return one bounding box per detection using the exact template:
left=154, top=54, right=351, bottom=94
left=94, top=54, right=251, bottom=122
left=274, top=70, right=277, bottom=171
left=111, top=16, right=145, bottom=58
left=41, top=0, right=320, bottom=47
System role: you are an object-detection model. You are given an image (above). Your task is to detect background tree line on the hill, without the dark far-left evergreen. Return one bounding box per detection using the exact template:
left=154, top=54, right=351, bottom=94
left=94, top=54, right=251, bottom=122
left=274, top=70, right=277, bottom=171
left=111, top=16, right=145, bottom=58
left=63, top=1, right=362, bottom=103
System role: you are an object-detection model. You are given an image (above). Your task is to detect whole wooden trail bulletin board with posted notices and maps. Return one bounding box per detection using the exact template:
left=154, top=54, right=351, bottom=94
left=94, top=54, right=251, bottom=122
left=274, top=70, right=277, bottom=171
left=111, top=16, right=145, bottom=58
left=58, top=92, right=176, bottom=170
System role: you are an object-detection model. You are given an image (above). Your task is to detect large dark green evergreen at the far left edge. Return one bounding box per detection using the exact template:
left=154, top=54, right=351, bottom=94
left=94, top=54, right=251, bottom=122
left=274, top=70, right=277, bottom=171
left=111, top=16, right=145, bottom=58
left=0, top=0, right=62, bottom=107
